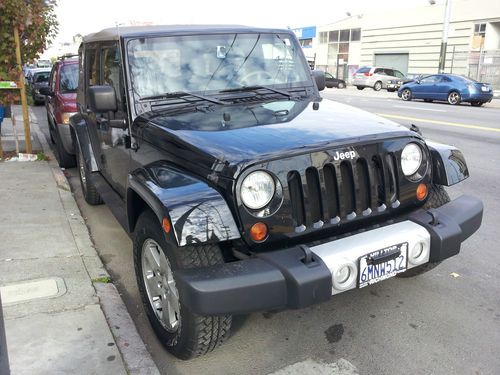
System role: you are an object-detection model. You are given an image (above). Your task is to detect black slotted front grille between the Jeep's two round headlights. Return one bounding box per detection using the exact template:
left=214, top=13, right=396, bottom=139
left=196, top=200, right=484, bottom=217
left=287, top=153, right=399, bottom=232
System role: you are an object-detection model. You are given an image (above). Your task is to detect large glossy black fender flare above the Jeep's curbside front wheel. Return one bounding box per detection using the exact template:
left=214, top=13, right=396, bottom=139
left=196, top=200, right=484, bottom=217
left=127, top=163, right=240, bottom=246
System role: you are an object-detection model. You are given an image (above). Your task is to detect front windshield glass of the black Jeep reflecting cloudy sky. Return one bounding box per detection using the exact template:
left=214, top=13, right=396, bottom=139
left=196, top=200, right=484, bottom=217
left=127, top=34, right=311, bottom=99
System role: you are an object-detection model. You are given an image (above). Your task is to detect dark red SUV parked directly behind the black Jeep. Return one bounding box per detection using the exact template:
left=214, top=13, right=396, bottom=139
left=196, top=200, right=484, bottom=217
left=41, top=56, right=78, bottom=168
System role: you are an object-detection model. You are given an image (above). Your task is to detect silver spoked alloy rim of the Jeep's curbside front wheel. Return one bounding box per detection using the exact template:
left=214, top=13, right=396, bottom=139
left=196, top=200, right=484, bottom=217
left=141, top=238, right=180, bottom=332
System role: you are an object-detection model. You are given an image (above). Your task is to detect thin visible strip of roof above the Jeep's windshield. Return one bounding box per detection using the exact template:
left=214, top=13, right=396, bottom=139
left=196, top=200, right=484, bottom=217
left=83, top=25, right=292, bottom=43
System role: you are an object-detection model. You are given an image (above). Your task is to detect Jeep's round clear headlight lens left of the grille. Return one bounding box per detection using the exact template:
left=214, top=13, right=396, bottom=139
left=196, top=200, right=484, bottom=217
left=240, top=171, right=276, bottom=210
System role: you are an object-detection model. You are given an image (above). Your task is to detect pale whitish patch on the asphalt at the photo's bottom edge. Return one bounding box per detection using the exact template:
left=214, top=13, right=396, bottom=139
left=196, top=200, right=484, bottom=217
left=269, top=358, right=359, bottom=375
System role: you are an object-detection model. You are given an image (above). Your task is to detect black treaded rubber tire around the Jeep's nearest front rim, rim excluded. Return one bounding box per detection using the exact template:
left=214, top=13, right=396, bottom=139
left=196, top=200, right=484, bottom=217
left=134, top=210, right=232, bottom=359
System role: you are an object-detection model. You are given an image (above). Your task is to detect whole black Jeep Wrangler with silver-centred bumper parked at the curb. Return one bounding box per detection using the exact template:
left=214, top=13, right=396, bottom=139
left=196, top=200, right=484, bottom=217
left=71, top=26, right=483, bottom=359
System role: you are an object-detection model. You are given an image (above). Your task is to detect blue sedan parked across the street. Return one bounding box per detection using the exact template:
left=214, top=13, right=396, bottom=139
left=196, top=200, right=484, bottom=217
left=398, top=74, right=493, bottom=107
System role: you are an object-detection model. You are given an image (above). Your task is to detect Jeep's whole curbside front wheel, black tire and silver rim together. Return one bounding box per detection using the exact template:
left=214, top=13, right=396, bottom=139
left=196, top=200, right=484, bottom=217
left=134, top=210, right=232, bottom=359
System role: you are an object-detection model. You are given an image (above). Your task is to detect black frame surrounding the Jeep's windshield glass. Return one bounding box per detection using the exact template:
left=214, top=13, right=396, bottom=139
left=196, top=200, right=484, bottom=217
left=122, top=29, right=319, bottom=117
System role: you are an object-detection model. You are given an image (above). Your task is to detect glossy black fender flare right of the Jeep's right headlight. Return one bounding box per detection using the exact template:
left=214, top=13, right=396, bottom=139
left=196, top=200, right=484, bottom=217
left=426, top=141, right=469, bottom=186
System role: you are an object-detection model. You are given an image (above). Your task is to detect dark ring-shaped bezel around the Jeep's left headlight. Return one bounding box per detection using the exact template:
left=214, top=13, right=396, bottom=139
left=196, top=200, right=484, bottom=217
left=236, top=169, right=283, bottom=218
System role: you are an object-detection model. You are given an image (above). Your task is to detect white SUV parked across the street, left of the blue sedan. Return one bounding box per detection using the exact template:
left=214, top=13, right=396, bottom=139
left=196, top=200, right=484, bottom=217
left=352, top=66, right=406, bottom=91
